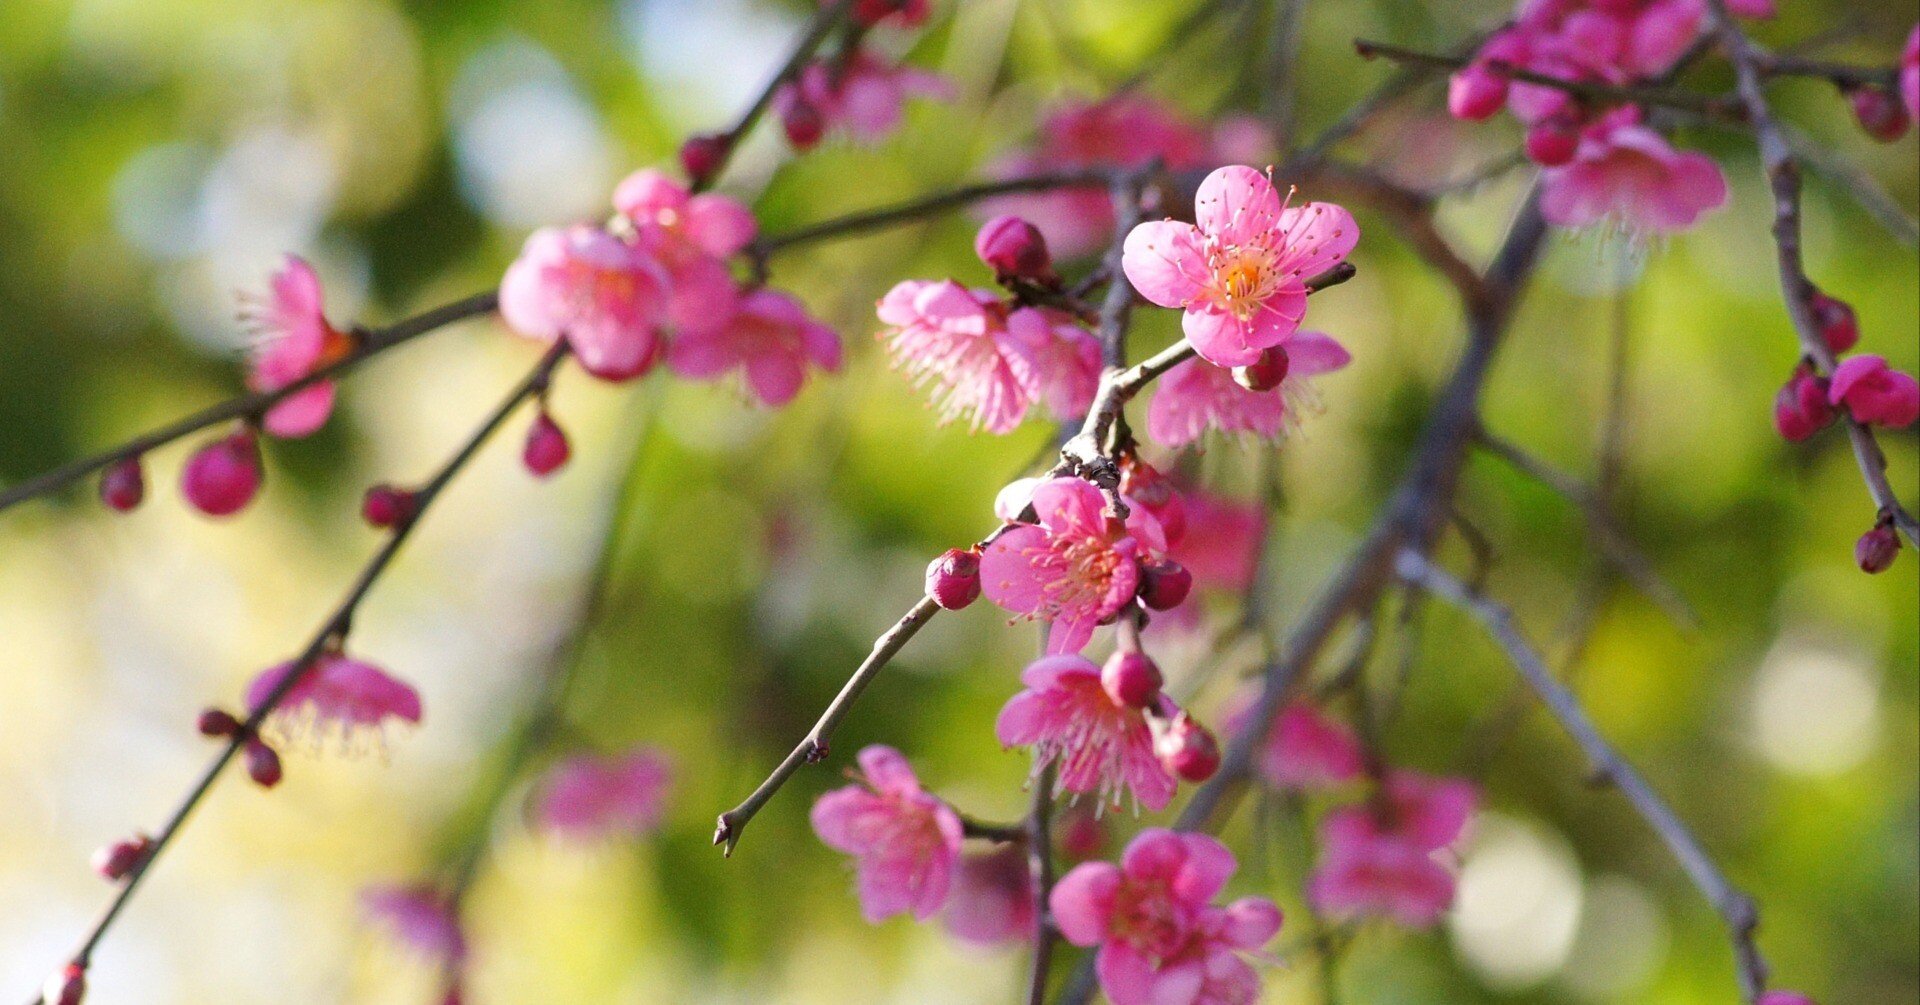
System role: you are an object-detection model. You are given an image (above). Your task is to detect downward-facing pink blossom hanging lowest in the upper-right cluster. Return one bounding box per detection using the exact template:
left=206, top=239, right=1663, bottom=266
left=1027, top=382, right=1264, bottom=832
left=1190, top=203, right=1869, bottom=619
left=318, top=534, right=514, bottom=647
left=1540, top=106, right=1726, bottom=234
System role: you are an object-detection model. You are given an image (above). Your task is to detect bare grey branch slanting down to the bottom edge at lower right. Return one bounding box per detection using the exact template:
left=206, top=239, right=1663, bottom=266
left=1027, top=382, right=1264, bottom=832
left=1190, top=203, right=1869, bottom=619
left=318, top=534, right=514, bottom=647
left=1398, top=550, right=1766, bottom=1003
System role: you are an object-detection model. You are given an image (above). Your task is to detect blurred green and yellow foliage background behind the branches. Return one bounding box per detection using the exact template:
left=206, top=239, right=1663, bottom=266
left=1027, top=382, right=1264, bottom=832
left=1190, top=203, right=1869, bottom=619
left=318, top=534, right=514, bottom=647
left=0, top=0, right=1920, bottom=1005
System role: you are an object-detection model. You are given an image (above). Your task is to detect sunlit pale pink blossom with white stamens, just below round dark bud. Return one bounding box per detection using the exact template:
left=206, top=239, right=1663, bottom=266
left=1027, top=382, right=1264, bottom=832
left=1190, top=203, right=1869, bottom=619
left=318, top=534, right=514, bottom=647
left=876, top=279, right=1100, bottom=432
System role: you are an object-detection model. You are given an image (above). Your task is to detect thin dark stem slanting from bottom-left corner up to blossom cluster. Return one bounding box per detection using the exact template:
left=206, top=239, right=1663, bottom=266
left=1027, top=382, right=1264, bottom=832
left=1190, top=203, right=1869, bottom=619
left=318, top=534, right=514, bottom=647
left=36, top=342, right=566, bottom=1001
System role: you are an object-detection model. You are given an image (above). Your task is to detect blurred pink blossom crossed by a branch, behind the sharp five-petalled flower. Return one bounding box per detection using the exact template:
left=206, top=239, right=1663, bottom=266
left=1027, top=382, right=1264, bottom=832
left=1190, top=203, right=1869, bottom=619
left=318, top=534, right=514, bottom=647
left=981, top=94, right=1212, bottom=257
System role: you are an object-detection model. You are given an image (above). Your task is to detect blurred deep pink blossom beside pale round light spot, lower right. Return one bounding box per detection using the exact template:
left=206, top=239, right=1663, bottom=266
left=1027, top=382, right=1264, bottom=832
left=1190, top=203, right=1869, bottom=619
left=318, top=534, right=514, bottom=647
left=1308, top=772, right=1478, bottom=928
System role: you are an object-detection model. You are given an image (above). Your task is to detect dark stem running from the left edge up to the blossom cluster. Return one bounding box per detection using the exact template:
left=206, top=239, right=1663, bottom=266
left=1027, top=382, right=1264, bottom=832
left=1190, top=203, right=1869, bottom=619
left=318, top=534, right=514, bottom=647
left=0, top=292, right=497, bottom=511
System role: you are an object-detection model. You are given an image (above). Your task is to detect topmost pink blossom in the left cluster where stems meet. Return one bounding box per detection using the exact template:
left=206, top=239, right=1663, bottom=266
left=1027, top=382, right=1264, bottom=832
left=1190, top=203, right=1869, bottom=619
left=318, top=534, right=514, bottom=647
left=612, top=167, right=756, bottom=334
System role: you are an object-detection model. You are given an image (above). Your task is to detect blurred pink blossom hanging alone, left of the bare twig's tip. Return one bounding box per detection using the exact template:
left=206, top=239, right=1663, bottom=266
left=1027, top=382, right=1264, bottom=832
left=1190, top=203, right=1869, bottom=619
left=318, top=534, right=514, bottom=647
left=532, top=748, right=674, bottom=842
